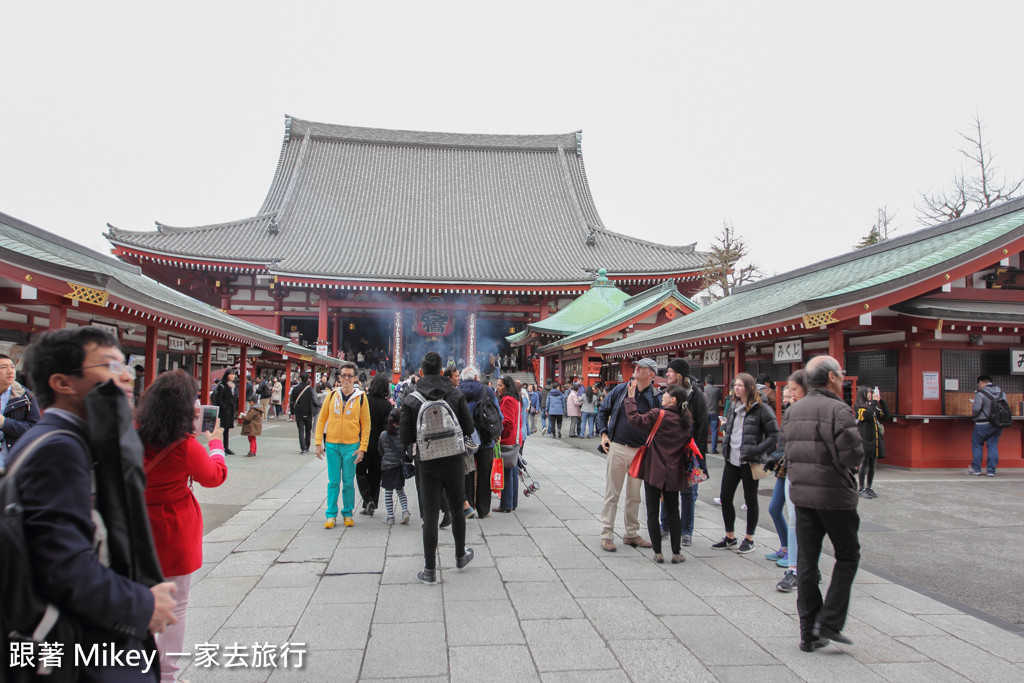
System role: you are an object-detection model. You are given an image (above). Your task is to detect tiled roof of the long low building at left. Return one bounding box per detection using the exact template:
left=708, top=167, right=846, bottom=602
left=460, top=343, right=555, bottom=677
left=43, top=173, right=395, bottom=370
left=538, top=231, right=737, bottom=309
left=0, top=213, right=329, bottom=361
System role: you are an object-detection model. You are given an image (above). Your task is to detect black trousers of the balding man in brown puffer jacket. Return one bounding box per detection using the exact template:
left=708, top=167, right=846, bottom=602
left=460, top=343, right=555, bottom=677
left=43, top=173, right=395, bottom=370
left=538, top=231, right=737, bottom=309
left=797, top=507, right=860, bottom=640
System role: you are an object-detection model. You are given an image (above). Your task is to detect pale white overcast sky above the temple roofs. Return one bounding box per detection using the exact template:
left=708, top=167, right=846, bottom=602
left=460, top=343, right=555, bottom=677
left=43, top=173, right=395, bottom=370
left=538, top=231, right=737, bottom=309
left=0, top=0, right=1024, bottom=280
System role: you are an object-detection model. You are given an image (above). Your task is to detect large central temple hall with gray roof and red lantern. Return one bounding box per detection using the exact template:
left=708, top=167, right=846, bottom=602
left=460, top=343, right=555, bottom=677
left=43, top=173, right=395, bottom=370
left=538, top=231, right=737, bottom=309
left=105, top=117, right=706, bottom=380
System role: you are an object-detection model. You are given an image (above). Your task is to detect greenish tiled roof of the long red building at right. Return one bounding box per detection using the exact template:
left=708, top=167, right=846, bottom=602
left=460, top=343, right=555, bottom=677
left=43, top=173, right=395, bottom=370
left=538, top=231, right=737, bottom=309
left=598, top=199, right=1024, bottom=354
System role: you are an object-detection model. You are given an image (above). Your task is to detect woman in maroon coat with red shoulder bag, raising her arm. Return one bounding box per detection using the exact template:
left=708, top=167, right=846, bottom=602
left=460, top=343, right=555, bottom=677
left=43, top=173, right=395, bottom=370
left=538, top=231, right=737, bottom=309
left=626, top=380, right=693, bottom=564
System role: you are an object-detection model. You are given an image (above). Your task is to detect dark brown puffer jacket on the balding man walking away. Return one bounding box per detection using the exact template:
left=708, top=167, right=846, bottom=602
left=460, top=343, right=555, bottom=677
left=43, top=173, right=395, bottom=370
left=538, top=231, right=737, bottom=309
left=782, top=387, right=864, bottom=510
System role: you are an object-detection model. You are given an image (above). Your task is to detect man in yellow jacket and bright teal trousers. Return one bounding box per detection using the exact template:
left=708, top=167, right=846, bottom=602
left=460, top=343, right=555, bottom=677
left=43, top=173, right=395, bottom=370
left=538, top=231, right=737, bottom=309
left=316, top=361, right=370, bottom=528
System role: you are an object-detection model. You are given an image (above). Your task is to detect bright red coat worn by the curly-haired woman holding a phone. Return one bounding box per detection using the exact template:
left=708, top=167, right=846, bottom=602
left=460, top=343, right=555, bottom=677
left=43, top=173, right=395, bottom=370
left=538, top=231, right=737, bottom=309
left=144, top=435, right=227, bottom=577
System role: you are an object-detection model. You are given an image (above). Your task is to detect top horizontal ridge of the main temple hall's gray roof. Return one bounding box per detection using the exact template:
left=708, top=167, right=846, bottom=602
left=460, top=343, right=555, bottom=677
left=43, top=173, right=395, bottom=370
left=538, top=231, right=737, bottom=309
left=286, top=117, right=583, bottom=152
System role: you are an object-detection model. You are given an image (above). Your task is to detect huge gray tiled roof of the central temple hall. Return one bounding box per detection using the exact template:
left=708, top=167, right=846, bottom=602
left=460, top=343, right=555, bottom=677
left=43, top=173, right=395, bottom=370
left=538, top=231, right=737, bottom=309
left=108, top=119, right=705, bottom=285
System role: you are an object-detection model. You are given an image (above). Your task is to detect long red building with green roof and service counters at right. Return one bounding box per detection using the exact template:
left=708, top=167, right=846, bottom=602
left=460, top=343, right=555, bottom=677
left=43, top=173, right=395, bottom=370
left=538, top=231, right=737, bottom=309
left=597, top=200, right=1024, bottom=468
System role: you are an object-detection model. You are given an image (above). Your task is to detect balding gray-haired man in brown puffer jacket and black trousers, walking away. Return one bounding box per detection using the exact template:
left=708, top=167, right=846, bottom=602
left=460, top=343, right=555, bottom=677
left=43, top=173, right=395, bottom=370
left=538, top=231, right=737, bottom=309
left=782, top=355, right=864, bottom=652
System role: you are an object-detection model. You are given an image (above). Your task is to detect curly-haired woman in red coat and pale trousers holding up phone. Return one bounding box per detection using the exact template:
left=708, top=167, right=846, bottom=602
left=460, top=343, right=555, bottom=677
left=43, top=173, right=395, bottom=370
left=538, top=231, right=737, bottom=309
left=135, top=370, right=227, bottom=683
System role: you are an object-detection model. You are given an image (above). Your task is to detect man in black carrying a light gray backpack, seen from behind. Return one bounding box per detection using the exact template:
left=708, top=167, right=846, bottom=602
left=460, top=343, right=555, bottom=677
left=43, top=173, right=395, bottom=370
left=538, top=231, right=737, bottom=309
left=398, top=351, right=473, bottom=586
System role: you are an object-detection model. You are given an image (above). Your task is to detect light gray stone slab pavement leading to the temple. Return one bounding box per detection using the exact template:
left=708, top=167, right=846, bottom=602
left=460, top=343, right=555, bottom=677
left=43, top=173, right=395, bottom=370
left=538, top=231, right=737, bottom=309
left=182, top=422, right=1024, bottom=682
